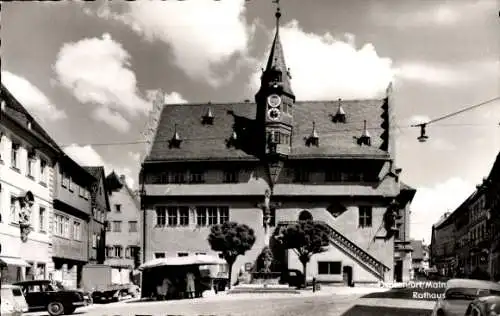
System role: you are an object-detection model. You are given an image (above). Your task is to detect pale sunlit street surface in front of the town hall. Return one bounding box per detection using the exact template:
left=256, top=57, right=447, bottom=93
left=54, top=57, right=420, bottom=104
left=23, top=289, right=433, bottom=316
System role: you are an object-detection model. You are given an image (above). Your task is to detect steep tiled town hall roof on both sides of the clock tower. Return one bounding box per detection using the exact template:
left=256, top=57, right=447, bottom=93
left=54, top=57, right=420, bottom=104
left=146, top=99, right=389, bottom=162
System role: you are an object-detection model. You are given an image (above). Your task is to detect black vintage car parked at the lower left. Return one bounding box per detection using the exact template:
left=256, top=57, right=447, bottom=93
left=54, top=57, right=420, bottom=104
left=14, top=280, right=89, bottom=316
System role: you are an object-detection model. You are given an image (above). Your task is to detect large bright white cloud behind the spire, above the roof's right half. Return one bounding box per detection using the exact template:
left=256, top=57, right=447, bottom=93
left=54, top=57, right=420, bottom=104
left=249, top=21, right=393, bottom=100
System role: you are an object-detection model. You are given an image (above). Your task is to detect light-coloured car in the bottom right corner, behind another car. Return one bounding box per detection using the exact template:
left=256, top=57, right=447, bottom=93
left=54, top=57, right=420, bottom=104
left=432, top=279, right=500, bottom=316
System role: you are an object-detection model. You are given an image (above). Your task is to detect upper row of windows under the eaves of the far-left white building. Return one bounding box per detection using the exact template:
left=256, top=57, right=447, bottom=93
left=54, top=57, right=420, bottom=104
left=0, top=135, right=49, bottom=186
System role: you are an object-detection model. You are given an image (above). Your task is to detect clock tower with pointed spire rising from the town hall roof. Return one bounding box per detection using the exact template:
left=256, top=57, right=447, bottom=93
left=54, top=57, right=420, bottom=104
left=255, top=1, right=295, bottom=183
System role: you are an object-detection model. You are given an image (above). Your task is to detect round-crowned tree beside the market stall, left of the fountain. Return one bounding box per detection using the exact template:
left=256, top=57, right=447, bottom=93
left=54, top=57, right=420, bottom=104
left=208, top=222, right=255, bottom=288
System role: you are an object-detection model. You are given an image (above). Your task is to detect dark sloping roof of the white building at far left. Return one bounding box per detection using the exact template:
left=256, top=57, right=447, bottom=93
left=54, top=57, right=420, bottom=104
left=1, top=84, right=61, bottom=152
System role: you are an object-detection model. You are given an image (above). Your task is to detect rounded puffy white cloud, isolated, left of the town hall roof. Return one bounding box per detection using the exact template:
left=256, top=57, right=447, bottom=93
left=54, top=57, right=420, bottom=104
left=54, top=33, right=151, bottom=127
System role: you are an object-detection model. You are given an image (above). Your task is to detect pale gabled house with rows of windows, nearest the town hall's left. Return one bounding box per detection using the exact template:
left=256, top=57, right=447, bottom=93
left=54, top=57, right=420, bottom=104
left=105, top=171, right=141, bottom=273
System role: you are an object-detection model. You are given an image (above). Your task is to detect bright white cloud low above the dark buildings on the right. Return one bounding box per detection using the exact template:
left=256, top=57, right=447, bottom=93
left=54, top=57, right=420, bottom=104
left=410, top=178, right=475, bottom=243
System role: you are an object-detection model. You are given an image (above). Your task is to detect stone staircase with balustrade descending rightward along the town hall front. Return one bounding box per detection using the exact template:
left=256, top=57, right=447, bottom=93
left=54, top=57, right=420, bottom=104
left=277, top=221, right=390, bottom=281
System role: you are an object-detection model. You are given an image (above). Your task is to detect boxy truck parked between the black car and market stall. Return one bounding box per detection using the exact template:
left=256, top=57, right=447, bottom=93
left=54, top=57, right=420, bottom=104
left=82, top=264, right=139, bottom=303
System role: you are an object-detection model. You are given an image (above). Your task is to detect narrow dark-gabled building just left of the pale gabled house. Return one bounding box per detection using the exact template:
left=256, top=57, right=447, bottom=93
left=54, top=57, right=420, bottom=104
left=84, top=166, right=110, bottom=264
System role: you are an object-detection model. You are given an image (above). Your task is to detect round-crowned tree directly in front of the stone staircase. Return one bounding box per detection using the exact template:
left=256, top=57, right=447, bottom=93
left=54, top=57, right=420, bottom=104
left=277, top=220, right=330, bottom=286
